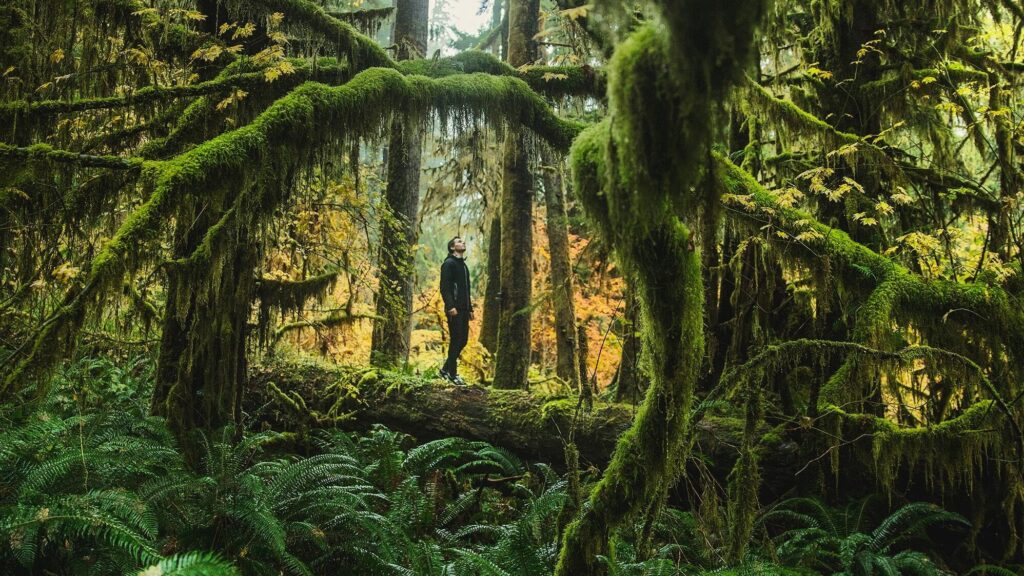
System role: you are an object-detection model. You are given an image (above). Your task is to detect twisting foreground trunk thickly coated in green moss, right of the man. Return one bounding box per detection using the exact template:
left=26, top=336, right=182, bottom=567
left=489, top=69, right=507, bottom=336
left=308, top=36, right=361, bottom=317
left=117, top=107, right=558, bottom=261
left=555, top=2, right=761, bottom=565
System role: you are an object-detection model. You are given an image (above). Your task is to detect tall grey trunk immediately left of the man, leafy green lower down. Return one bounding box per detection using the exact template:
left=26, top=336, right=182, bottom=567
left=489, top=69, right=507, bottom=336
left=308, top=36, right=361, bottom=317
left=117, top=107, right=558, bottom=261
left=370, top=0, right=429, bottom=366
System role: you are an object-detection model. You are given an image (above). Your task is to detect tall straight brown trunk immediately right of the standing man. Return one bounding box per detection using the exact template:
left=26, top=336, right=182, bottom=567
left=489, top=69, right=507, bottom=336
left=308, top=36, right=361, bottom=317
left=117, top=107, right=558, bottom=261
left=495, top=0, right=540, bottom=388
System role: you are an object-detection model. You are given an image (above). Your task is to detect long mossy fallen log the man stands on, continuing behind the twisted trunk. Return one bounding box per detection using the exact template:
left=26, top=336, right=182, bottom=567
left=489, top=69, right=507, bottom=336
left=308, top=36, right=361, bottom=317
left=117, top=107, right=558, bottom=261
left=246, top=362, right=1024, bottom=558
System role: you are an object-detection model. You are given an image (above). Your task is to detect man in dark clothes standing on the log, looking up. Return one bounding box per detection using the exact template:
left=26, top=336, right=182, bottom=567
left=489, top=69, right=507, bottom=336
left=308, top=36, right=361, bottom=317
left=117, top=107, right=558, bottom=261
left=440, top=236, right=473, bottom=386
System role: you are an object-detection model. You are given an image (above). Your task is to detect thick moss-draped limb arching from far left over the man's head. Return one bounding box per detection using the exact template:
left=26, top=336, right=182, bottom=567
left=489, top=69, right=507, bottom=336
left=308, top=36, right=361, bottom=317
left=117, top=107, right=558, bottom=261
left=4, top=69, right=581, bottom=389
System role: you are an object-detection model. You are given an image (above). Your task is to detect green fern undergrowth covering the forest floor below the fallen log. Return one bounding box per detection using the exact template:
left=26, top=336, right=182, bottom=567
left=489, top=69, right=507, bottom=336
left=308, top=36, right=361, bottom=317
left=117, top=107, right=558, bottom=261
left=0, top=358, right=1002, bottom=576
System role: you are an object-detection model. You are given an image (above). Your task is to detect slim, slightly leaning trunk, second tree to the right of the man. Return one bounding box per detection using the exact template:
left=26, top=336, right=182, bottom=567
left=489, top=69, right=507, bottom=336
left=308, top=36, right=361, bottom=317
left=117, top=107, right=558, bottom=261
left=542, top=150, right=586, bottom=388
